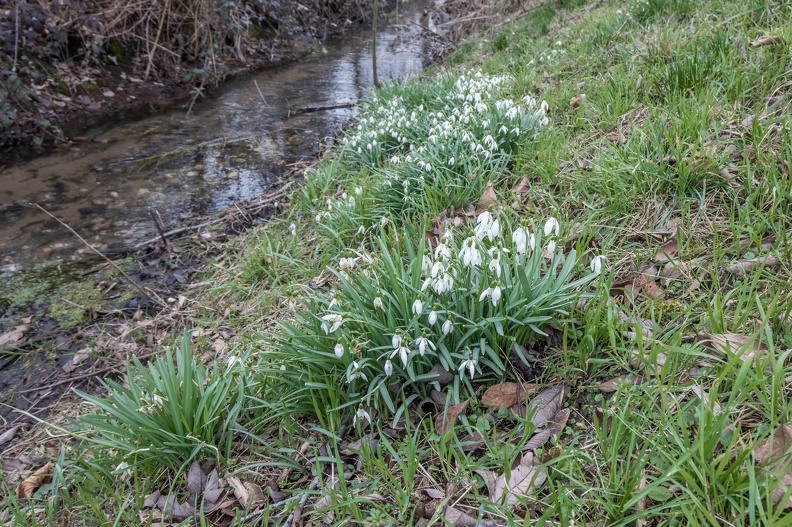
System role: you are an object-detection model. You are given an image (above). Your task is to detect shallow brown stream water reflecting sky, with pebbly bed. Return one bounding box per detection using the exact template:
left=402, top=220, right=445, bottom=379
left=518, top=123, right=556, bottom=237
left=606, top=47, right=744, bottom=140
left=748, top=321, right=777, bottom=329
left=0, top=2, right=430, bottom=275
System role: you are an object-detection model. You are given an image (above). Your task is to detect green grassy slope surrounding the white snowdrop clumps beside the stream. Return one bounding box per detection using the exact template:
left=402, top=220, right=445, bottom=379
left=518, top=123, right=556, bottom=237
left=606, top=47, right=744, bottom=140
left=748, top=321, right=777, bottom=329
left=3, top=0, right=792, bottom=526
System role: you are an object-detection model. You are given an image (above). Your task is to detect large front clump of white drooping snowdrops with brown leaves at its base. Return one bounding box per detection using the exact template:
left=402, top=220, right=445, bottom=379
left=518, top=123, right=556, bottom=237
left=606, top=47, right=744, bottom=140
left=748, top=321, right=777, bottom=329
left=272, top=211, right=602, bottom=426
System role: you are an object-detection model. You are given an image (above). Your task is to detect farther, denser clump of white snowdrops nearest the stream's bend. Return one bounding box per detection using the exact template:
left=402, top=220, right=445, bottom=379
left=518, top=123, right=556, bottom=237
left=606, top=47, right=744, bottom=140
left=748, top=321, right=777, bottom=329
left=303, top=72, right=548, bottom=234
